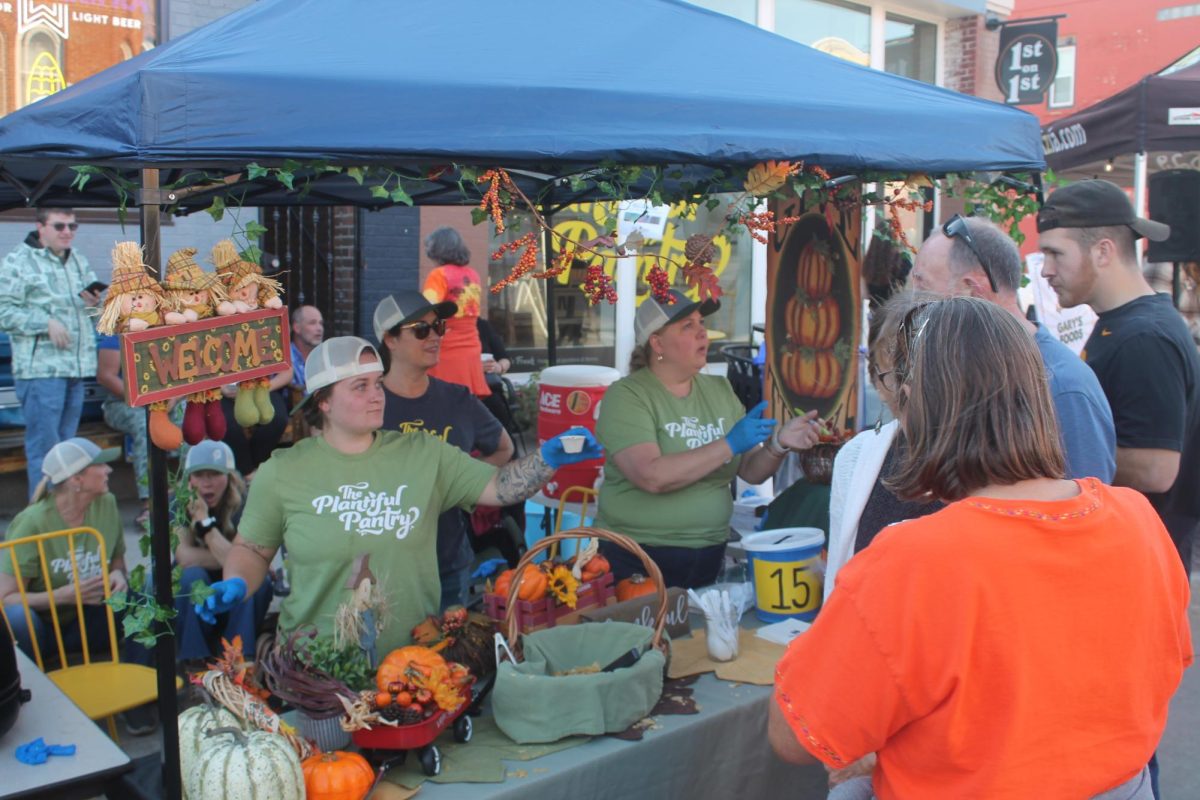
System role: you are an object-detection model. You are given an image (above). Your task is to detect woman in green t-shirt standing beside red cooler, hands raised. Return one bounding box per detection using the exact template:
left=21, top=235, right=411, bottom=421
left=596, top=290, right=817, bottom=588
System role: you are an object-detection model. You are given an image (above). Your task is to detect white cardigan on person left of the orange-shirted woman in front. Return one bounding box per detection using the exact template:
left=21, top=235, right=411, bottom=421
left=824, top=420, right=899, bottom=601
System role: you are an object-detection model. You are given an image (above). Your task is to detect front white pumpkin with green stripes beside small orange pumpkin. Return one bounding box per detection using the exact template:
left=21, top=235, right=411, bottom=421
left=185, top=728, right=305, bottom=800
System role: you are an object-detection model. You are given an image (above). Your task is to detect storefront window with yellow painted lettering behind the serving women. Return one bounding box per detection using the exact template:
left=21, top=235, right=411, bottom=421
left=487, top=203, right=751, bottom=371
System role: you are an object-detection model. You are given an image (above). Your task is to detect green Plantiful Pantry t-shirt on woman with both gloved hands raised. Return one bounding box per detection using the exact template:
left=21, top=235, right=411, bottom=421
left=596, top=369, right=745, bottom=547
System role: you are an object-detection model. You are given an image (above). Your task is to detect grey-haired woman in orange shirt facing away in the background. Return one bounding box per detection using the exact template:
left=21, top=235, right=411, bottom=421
left=421, top=227, right=492, bottom=397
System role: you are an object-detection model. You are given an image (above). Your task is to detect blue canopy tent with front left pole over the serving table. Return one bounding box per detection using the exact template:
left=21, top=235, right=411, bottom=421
left=0, top=0, right=1044, bottom=798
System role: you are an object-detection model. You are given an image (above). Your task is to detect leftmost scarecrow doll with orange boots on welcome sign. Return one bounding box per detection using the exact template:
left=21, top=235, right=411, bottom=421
left=96, top=241, right=184, bottom=450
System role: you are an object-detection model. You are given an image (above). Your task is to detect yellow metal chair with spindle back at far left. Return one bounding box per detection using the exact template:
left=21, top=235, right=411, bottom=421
left=0, top=528, right=158, bottom=740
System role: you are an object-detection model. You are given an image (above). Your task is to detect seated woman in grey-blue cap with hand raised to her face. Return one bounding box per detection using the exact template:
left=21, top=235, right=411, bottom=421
left=175, top=439, right=272, bottom=664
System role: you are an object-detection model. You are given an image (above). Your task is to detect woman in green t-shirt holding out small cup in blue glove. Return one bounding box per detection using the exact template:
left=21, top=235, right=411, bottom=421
left=197, top=338, right=602, bottom=656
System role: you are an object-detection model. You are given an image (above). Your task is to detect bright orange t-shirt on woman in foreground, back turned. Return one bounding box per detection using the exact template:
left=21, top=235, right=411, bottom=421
left=775, top=479, right=1193, bottom=800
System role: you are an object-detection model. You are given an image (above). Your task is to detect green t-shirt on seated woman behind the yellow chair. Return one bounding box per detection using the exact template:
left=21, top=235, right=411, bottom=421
left=0, top=492, right=125, bottom=606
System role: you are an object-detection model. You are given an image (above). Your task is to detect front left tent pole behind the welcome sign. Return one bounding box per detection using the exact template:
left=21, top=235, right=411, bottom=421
left=138, top=169, right=184, bottom=800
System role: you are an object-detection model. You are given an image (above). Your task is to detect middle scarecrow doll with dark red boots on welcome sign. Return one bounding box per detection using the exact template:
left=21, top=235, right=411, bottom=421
left=162, top=247, right=236, bottom=445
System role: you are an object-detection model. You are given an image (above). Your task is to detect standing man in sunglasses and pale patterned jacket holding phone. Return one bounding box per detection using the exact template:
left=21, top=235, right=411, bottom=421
left=0, top=209, right=102, bottom=494
